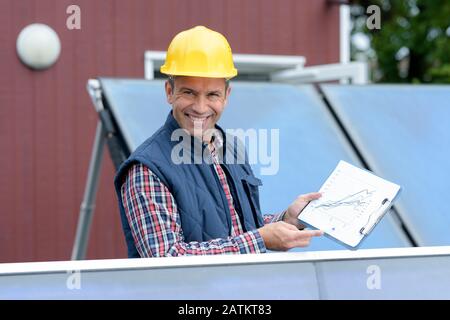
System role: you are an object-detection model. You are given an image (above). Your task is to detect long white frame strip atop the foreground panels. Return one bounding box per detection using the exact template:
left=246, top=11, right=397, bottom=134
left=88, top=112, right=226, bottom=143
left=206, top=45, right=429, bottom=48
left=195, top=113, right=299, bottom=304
left=0, top=246, right=450, bottom=276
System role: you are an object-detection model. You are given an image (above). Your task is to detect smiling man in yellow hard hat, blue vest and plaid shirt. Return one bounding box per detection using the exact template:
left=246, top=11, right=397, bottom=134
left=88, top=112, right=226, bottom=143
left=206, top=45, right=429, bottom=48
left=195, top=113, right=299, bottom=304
left=115, top=26, right=322, bottom=257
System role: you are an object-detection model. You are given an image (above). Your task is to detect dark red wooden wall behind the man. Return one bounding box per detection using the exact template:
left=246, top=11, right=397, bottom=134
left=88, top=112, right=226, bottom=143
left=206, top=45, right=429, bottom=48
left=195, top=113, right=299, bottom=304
left=0, top=0, right=339, bottom=263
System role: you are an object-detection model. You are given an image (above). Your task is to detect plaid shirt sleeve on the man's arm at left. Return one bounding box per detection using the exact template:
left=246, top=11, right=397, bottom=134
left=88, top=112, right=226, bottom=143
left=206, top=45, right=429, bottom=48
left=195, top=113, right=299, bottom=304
left=121, top=164, right=266, bottom=257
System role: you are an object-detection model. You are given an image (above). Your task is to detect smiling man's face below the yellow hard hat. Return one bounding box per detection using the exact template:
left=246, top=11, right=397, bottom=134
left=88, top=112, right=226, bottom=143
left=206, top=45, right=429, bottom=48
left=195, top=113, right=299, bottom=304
left=166, top=76, right=231, bottom=138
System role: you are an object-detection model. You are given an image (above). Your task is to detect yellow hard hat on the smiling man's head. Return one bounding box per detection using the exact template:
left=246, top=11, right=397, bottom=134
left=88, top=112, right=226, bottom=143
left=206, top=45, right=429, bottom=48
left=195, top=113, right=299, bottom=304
left=160, top=26, right=237, bottom=79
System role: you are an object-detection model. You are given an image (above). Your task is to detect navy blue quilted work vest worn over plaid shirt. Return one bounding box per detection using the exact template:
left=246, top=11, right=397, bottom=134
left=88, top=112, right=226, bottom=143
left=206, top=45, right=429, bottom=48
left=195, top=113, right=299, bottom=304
left=114, top=112, right=264, bottom=258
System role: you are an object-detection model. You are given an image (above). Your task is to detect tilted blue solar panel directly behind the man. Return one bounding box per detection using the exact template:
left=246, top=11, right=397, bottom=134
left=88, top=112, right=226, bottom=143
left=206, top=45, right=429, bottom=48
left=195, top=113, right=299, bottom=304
left=101, top=79, right=409, bottom=250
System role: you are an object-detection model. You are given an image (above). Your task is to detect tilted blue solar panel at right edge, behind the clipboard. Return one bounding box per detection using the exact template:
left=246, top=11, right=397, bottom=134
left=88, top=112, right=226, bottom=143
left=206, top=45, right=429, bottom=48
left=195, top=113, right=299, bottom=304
left=321, top=84, right=450, bottom=246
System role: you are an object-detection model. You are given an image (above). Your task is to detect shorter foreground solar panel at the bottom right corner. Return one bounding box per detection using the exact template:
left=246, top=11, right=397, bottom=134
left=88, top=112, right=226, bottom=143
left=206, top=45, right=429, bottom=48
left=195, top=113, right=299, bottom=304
left=316, top=256, right=450, bottom=300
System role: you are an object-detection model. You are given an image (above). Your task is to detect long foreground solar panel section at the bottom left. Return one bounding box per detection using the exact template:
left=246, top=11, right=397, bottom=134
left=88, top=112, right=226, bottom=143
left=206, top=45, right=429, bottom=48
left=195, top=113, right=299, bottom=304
left=0, top=258, right=318, bottom=300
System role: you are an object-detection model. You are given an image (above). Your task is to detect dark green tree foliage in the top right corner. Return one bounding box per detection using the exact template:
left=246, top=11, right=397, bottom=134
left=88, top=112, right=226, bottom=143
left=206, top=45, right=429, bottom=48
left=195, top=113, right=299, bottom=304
left=352, top=0, right=450, bottom=83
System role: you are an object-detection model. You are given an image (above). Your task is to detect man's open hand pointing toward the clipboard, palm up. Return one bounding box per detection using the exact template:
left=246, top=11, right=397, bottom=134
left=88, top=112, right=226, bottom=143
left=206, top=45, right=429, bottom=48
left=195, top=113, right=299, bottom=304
left=258, top=221, right=323, bottom=251
